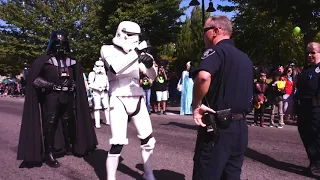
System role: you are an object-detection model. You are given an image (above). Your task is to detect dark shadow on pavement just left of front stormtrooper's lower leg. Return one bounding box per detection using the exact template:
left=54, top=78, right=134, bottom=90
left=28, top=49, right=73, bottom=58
left=83, top=149, right=108, bottom=180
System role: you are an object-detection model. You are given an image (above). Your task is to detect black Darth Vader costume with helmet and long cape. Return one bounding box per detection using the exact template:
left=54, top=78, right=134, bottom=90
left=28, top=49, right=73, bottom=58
left=17, top=31, right=98, bottom=167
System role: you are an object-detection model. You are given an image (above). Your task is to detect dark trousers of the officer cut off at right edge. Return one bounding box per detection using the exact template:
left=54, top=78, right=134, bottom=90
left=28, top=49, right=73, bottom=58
left=298, top=103, right=320, bottom=167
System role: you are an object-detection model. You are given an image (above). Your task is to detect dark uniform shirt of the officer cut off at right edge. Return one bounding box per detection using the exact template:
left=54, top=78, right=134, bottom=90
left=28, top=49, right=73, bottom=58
left=296, top=63, right=320, bottom=99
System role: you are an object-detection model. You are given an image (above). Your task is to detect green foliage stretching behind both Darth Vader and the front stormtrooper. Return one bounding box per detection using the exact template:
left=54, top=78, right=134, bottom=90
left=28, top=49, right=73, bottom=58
left=0, top=0, right=184, bottom=73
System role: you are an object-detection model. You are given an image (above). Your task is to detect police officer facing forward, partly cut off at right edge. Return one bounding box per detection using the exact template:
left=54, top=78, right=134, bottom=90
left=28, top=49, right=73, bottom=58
left=296, top=42, right=320, bottom=175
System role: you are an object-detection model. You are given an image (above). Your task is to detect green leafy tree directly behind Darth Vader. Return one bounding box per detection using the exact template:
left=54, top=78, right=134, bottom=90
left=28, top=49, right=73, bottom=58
left=0, top=0, right=104, bottom=74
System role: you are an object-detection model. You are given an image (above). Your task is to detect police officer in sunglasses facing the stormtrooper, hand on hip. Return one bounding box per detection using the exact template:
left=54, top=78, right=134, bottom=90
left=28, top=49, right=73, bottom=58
left=192, top=16, right=253, bottom=180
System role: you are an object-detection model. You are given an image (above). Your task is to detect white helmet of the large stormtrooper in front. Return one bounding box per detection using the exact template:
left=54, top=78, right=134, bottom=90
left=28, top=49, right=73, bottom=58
left=112, top=21, right=141, bottom=53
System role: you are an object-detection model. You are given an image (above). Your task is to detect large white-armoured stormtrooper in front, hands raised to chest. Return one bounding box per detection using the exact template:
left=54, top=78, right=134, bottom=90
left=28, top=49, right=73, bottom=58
left=100, top=21, right=157, bottom=180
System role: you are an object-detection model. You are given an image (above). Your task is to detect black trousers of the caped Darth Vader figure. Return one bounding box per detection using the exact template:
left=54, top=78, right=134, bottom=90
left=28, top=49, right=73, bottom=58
left=42, top=92, right=75, bottom=153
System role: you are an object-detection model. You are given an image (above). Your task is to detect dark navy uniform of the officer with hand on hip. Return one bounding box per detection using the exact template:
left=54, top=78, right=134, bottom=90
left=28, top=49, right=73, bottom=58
left=193, top=39, right=253, bottom=180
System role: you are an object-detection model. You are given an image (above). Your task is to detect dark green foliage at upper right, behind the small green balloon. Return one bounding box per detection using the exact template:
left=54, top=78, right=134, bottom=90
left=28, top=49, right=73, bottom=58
left=218, top=0, right=320, bottom=65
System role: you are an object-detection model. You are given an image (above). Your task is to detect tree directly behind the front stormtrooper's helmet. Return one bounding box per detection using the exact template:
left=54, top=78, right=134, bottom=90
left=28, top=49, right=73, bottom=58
left=100, top=0, right=185, bottom=54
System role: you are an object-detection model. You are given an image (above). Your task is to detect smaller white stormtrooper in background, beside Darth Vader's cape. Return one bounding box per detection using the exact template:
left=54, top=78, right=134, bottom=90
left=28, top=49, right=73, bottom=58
left=88, top=59, right=110, bottom=128
